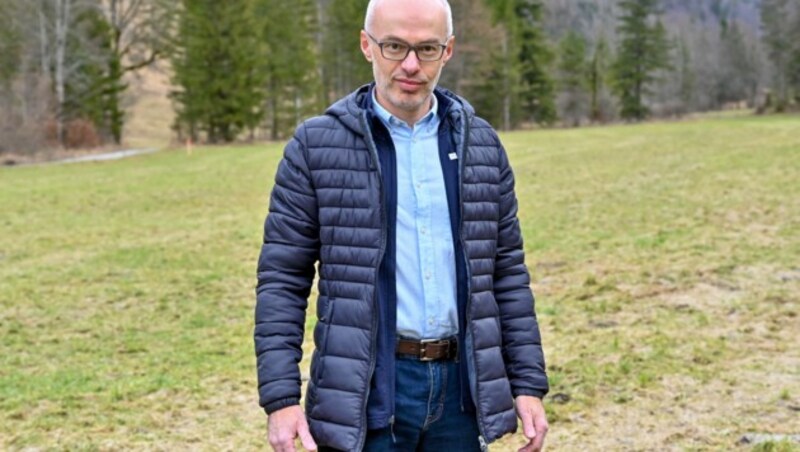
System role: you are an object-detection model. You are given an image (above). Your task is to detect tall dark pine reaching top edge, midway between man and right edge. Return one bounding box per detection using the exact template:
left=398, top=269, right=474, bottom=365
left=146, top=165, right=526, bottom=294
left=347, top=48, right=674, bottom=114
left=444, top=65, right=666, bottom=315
left=614, top=0, right=669, bottom=121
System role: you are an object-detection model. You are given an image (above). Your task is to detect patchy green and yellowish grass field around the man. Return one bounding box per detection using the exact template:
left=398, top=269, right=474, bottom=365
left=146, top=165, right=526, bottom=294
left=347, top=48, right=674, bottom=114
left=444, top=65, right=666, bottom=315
left=0, top=116, right=800, bottom=451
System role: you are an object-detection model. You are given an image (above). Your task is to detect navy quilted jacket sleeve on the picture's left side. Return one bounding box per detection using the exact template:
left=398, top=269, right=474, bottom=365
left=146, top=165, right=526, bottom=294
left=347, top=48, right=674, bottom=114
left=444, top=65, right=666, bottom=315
left=254, top=126, right=319, bottom=414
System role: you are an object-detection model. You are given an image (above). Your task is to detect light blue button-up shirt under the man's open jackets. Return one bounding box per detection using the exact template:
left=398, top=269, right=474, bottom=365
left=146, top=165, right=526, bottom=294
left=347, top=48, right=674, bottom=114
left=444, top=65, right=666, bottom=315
left=372, top=92, right=458, bottom=339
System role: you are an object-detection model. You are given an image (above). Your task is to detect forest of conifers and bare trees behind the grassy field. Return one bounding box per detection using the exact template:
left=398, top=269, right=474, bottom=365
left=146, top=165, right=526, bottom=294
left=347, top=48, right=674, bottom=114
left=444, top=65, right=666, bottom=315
left=0, top=0, right=800, bottom=153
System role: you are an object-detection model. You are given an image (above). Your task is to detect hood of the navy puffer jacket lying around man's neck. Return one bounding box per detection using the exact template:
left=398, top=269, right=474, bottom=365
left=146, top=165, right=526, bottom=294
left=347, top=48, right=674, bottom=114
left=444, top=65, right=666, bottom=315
left=325, top=82, right=475, bottom=136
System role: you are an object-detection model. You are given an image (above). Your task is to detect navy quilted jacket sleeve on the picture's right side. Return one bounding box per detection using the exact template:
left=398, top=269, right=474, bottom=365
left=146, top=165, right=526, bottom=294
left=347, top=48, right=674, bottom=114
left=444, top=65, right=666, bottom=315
left=494, top=140, right=549, bottom=398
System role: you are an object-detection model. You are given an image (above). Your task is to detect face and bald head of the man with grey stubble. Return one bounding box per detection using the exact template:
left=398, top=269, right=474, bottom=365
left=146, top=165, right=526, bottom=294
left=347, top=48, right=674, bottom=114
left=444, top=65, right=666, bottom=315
left=361, top=0, right=454, bottom=124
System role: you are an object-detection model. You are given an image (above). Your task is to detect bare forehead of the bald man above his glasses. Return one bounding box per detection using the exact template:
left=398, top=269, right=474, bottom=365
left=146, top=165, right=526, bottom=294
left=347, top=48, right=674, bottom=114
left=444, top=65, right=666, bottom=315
left=372, top=0, right=447, bottom=42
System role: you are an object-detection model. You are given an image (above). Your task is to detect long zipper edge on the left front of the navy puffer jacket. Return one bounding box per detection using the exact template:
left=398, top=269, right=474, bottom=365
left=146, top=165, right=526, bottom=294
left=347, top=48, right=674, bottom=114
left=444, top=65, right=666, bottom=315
left=358, top=112, right=386, bottom=450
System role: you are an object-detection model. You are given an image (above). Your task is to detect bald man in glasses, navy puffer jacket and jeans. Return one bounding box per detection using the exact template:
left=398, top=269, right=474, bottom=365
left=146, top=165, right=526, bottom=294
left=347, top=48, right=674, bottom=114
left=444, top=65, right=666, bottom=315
left=255, top=0, right=548, bottom=451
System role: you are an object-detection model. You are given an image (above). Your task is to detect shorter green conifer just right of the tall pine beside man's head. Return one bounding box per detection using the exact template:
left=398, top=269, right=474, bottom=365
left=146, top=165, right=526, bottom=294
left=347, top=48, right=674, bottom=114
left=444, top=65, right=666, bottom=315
left=558, top=31, right=590, bottom=127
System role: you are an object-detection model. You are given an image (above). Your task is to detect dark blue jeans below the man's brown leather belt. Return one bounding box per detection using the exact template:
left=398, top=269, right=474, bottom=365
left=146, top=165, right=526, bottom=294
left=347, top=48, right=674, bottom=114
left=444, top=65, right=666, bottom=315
left=364, top=355, right=481, bottom=452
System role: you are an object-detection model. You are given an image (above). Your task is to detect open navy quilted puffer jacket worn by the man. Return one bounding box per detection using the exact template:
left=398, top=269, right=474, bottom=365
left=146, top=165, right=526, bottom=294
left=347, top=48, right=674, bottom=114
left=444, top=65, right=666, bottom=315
left=254, top=86, right=548, bottom=450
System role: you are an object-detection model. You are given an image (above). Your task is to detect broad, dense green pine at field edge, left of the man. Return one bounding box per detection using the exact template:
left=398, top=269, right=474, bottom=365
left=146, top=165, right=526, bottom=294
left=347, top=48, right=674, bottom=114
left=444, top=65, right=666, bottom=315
left=171, top=0, right=266, bottom=143
